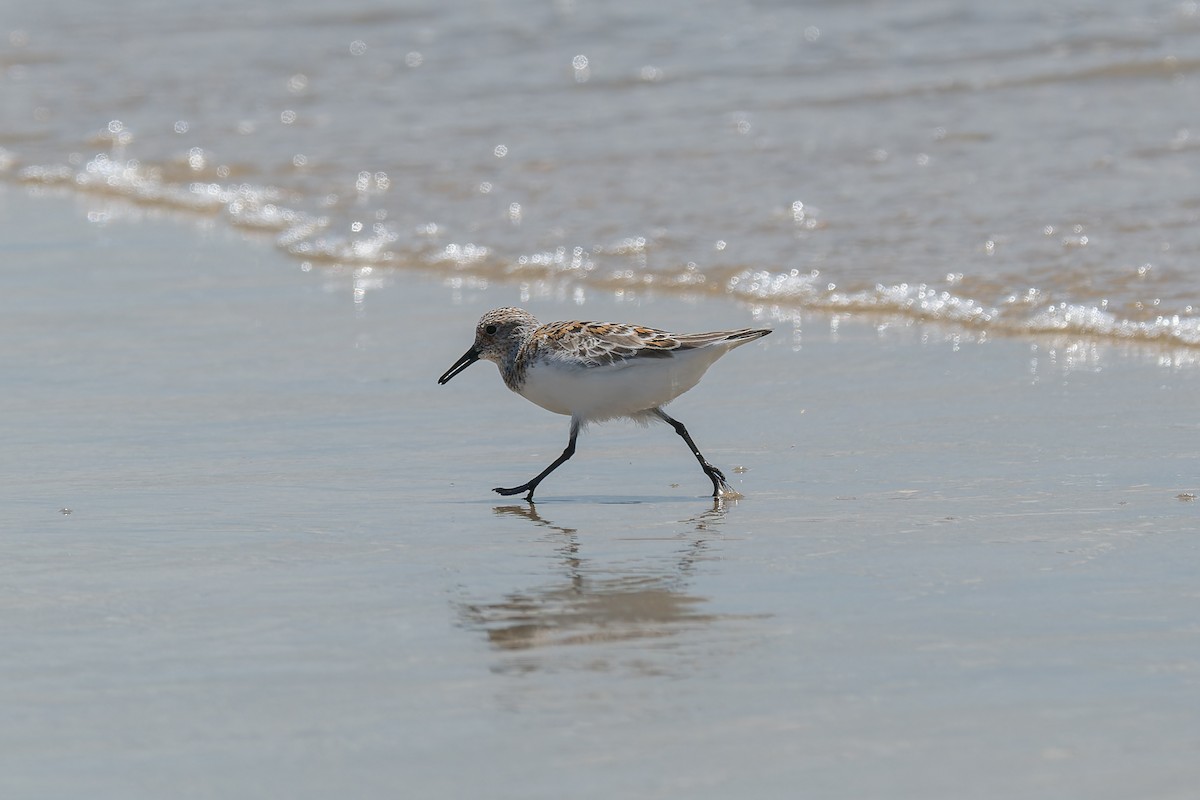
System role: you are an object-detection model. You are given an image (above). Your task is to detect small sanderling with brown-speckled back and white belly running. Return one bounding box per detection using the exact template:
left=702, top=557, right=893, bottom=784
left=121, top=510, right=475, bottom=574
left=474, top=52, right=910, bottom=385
left=438, top=308, right=770, bottom=503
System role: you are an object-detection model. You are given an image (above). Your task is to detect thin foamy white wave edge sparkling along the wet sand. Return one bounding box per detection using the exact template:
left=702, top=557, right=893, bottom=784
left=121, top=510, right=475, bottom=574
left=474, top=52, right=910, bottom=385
left=9, top=149, right=1200, bottom=348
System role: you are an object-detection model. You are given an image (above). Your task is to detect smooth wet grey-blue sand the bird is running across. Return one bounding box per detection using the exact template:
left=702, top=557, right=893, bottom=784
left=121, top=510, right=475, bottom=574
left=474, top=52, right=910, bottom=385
left=0, top=187, right=1200, bottom=798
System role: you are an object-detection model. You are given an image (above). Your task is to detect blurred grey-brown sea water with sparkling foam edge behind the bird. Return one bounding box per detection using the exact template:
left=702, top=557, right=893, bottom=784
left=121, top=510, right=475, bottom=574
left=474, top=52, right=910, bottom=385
left=0, top=0, right=1200, bottom=347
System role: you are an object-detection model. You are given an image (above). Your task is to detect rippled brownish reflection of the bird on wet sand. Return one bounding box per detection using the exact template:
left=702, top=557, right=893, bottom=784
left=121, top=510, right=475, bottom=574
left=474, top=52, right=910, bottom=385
left=461, top=500, right=732, bottom=670
